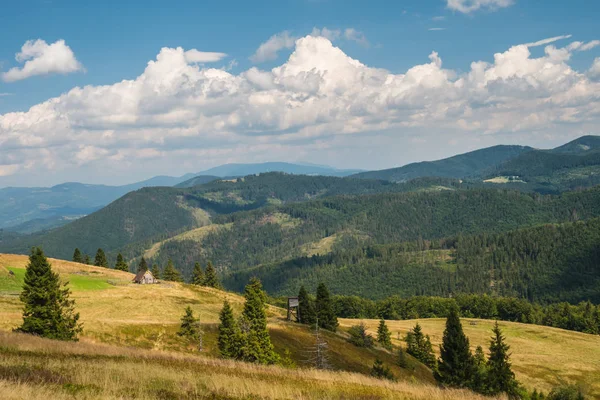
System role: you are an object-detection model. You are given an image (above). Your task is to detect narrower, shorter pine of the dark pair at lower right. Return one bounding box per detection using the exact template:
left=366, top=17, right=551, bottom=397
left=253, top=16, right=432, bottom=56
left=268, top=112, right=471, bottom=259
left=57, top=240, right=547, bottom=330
left=487, top=321, right=519, bottom=398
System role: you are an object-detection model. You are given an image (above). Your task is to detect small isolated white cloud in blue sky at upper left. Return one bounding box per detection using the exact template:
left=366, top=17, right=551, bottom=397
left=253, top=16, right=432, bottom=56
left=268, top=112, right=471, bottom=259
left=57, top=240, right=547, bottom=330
left=2, top=39, right=84, bottom=82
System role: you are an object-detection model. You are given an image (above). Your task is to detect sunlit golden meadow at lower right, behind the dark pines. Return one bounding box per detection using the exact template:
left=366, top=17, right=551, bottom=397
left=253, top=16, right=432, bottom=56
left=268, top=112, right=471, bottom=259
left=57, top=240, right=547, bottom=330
left=340, top=318, right=600, bottom=398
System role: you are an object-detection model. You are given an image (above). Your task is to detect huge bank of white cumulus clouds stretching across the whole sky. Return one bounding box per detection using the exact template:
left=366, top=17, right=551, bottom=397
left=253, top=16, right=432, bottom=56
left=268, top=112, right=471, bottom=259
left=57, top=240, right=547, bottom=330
left=0, top=35, right=600, bottom=182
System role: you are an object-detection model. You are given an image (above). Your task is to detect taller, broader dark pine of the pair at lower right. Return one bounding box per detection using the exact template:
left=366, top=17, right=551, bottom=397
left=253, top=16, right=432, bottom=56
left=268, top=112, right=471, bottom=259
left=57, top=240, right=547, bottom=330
left=434, top=306, right=475, bottom=387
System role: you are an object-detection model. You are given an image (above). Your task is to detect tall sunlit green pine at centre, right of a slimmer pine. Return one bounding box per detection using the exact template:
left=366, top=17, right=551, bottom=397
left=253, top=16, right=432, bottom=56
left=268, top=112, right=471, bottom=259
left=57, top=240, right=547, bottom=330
left=242, top=278, right=279, bottom=364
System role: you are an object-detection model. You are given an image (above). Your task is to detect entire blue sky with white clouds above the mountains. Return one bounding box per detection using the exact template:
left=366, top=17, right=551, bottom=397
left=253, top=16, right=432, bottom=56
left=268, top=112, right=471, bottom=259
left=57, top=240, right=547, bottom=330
left=0, top=0, right=600, bottom=187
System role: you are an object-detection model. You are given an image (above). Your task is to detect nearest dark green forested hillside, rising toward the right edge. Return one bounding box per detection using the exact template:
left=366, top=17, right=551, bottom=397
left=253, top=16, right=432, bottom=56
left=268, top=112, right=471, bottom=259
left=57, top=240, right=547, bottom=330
left=225, top=219, right=600, bottom=303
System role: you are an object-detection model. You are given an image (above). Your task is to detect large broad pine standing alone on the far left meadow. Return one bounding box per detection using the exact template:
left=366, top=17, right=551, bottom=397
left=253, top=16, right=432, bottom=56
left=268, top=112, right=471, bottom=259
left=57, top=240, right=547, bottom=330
left=16, top=248, right=82, bottom=341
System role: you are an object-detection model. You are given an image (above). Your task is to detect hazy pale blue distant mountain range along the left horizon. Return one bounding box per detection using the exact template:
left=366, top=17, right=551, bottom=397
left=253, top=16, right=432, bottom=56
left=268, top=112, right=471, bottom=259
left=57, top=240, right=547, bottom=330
left=0, top=162, right=360, bottom=233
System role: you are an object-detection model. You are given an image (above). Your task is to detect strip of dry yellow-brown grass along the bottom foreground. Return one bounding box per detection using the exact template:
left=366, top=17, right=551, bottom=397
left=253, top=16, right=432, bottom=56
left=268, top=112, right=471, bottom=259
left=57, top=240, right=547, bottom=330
left=0, top=332, right=492, bottom=400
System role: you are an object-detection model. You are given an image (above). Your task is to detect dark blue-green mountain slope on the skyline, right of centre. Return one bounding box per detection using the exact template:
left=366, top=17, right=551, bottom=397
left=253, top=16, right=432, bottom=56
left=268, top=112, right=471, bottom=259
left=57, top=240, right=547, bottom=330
left=352, top=146, right=532, bottom=182
